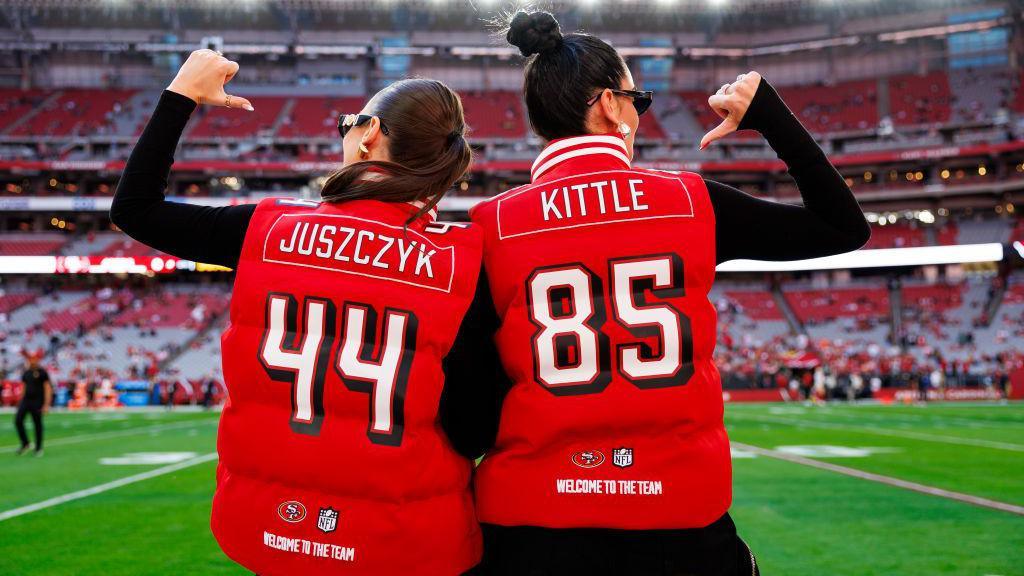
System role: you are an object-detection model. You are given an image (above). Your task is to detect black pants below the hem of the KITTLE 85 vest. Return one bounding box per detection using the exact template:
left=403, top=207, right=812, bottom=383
left=472, top=515, right=759, bottom=576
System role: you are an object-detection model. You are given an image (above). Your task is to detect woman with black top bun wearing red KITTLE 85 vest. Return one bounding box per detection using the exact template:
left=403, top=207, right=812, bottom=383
left=471, top=11, right=869, bottom=576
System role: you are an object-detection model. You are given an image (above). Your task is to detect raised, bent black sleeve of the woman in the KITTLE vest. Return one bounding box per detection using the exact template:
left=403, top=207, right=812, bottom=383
left=706, top=79, right=871, bottom=263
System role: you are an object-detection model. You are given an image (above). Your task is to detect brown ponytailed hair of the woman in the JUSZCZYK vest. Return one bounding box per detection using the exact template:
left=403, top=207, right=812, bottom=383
left=321, top=79, right=473, bottom=222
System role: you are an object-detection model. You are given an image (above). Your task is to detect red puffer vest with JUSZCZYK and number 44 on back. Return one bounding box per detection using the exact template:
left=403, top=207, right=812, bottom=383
left=211, top=199, right=482, bottom=576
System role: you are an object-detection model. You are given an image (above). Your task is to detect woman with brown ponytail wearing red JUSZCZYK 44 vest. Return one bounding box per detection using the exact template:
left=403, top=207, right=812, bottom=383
left=111, top=50, right=501, bottom=576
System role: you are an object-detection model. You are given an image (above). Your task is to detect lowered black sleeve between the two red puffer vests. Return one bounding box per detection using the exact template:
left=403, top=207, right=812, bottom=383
left=439, top=270, right=512, bottom=459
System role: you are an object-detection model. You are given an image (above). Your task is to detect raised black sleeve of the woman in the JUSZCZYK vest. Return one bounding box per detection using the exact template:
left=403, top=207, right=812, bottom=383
left=111, top=90, right=256, bottom=268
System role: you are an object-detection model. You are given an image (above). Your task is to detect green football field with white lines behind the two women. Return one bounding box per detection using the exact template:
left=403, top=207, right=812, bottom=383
left=0, top=403, right=1024, bottom=576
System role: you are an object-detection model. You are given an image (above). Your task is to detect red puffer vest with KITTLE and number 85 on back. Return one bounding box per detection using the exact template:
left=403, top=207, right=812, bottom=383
left=471, top=134, right=731, bottom=530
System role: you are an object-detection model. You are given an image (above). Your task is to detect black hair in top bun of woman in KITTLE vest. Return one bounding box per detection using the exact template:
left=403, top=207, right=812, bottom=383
left=505, top=11, right=626, bottom=140
